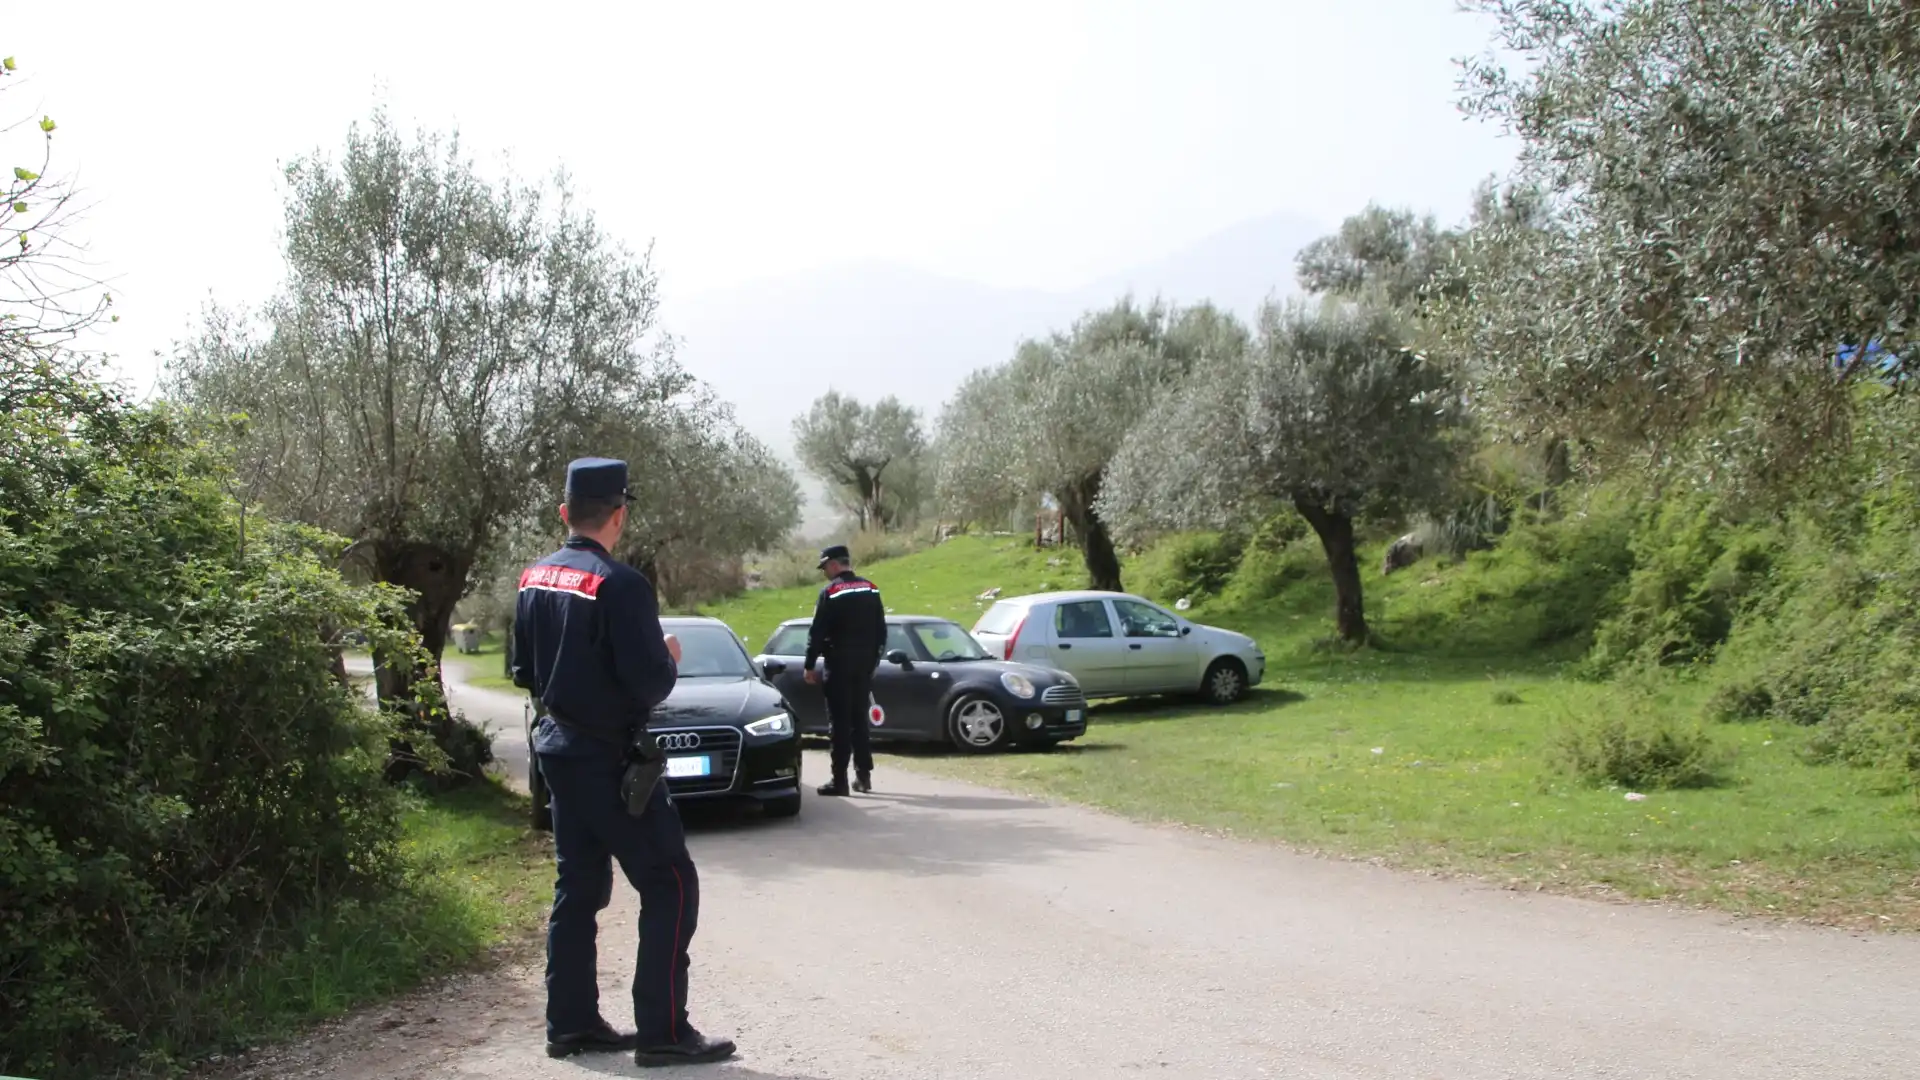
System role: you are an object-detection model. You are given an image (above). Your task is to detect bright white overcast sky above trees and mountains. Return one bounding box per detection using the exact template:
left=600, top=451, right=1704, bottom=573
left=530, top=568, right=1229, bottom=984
left=0, top=0, right=1511, bottom=395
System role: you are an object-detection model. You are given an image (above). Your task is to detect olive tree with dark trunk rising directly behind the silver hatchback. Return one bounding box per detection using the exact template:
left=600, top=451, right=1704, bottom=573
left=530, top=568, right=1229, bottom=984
left=941, top=298, right=1248, bottom=590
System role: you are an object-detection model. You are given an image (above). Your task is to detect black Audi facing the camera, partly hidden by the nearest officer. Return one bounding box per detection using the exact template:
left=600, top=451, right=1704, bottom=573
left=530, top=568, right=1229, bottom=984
left=526, top=617, right=801, bottom=830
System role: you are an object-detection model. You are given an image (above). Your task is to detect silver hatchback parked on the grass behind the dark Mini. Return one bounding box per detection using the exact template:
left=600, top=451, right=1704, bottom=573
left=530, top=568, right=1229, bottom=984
left=973, top=590, right=1267, bottom=705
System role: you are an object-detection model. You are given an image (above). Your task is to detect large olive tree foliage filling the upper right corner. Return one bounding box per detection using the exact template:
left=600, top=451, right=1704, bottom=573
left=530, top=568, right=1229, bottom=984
left=1457, top=0, right=1920, bottom=480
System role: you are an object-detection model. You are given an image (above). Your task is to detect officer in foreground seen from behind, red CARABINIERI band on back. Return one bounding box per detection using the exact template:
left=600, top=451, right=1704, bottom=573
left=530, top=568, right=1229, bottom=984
left=513, top=457, right=733, bottom=1065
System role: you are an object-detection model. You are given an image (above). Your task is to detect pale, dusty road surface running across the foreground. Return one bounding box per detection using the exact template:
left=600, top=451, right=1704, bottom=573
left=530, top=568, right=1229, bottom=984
left=244, top=661, right=1920, bottom=1080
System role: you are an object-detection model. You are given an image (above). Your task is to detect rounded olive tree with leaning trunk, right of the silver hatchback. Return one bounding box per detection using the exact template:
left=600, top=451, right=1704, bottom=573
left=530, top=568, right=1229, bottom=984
left=1096, top=298, right=1465, bottom=642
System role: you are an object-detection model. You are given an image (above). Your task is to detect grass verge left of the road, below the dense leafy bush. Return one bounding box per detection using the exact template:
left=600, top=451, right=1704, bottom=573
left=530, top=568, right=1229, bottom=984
left=148, top=780, right=553, bottom=1074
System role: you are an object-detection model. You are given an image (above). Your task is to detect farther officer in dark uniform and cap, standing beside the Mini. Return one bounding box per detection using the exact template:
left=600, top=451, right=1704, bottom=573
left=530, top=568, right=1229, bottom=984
left=803, top=544, right=887, bottom=796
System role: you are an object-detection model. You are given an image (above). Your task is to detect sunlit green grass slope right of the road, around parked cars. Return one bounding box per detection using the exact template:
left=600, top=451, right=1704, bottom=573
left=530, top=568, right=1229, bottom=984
left=707, top=538, right=1920, bottom=928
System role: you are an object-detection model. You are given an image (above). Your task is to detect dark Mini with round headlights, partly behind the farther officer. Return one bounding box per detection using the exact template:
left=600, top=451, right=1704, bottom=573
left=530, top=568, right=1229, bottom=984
left=755, top=615, right=1087, bottom=753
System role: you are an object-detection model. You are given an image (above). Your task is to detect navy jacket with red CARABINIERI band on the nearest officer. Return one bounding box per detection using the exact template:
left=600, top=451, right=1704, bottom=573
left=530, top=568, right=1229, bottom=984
left=513, top=536, right=680, bottom=757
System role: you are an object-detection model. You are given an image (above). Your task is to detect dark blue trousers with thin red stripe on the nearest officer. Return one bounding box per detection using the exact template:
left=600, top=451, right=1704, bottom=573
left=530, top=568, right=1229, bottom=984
left=538, top=753, right=701, bottom=1045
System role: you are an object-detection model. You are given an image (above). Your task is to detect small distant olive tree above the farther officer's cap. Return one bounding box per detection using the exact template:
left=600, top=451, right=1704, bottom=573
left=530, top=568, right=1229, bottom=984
left=793, top=390, right=927, bottom=528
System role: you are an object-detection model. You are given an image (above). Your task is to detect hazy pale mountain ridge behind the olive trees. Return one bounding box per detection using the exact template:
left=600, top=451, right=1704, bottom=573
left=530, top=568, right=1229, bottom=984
left=662, top=213, right=1329, bottom=536
